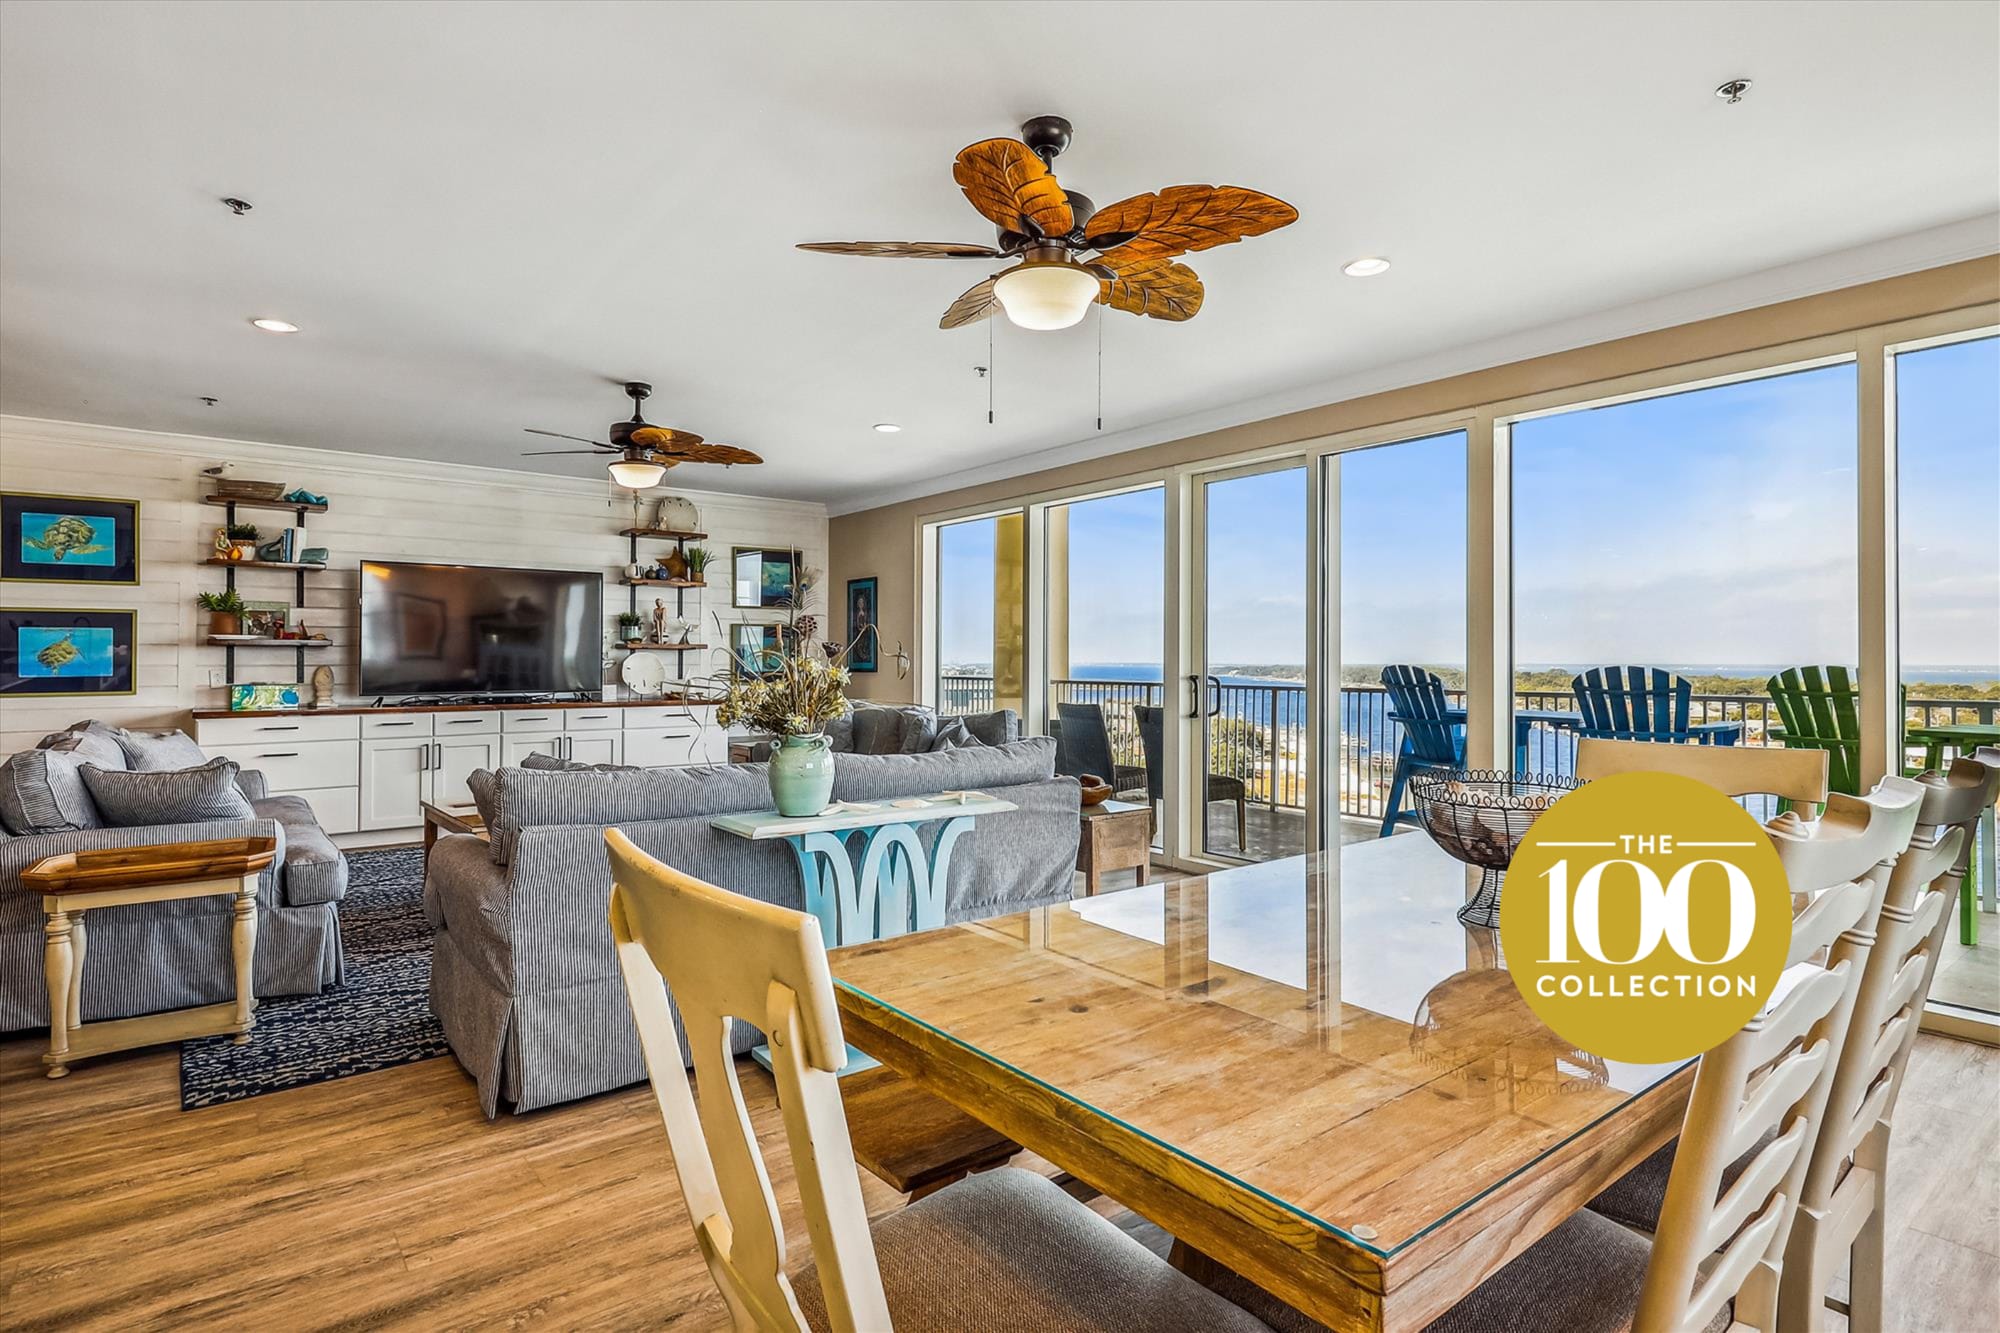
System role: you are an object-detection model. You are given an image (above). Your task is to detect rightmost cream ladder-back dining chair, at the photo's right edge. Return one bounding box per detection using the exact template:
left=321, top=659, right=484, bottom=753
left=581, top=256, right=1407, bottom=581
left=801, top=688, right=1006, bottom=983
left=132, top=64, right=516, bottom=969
left=1778, top=747, right=2000, bottom=1333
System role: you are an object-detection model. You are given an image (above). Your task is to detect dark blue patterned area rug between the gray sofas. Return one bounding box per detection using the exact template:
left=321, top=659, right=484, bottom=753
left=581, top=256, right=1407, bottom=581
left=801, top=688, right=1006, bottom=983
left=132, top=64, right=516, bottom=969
left=180, top=847, right=450, bottom=1111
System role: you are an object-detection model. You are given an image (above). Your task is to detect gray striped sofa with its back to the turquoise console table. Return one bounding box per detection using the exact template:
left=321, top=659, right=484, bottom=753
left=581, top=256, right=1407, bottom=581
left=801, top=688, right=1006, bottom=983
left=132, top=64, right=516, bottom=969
left=424, top=737, right=1078, bottom=1117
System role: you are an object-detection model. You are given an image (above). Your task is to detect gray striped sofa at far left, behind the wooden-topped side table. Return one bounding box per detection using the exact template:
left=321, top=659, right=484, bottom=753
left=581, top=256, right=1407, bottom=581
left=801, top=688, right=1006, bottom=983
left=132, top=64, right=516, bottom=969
left=0, top=725, right=348, bottom=1033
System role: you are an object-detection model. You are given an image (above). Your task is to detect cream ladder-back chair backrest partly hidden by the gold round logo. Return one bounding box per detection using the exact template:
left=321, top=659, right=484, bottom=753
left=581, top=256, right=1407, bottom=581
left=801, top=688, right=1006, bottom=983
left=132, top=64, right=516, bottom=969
left=1634, top=779, right=1922, bottom=1333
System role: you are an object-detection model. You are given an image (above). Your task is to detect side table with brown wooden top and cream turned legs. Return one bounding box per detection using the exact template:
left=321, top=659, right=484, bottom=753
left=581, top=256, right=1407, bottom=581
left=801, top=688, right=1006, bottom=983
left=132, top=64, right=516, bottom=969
left=20, top=839, right=278, bottom=1079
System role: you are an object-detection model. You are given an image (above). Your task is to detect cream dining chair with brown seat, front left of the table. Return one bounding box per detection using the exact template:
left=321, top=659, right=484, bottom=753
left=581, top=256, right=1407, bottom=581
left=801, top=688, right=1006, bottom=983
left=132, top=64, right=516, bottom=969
left=604, top=829, right=1268, bottom=1333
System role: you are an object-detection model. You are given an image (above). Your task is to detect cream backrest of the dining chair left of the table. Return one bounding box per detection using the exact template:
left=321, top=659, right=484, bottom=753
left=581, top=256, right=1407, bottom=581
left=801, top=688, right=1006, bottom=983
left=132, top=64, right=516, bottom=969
left=604, top=829, right=890, bottom=1333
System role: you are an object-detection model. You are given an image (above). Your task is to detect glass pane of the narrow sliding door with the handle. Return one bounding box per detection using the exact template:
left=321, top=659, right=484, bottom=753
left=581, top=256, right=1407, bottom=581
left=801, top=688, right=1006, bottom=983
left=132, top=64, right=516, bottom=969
left=1168, top=462, right=1312, bottom=861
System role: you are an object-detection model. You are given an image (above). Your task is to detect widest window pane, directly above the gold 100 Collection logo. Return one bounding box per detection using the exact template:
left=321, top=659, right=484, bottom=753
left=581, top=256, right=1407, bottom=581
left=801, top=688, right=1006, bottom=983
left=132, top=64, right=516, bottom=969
left=1512, top=362, right=1860, bottom=773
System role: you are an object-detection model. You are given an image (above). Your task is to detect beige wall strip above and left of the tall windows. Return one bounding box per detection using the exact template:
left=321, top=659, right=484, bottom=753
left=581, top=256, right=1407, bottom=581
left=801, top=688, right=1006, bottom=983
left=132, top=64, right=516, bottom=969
left=828, top=256, right=2000, bottom=701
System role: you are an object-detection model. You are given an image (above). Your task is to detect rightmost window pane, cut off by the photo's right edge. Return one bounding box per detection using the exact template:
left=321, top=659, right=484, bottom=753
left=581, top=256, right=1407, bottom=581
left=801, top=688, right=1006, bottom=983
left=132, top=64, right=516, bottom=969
left=1892, top=326, right=2000, bottom=1013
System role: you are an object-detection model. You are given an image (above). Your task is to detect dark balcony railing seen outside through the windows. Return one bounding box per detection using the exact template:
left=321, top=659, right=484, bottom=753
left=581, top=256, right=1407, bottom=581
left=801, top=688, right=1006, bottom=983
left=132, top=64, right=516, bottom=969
left=940, top=677, right=2000, bottom=819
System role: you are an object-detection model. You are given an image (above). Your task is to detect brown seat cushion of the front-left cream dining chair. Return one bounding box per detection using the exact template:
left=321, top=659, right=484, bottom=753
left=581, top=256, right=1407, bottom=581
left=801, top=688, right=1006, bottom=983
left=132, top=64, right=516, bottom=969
left=792, top=1167, right=1268, bottom=1333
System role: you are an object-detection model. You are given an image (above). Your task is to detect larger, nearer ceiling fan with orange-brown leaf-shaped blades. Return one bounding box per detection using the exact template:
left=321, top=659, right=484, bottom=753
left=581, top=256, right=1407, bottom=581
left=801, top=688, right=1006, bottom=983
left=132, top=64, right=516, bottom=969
left=798, top=116, right=1298, bottom=328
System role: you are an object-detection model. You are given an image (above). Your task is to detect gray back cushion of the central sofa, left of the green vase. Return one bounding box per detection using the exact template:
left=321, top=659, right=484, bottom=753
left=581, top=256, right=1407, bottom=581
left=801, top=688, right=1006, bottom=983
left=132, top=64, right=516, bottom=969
left=472, top=765, right=770, bottom=865
